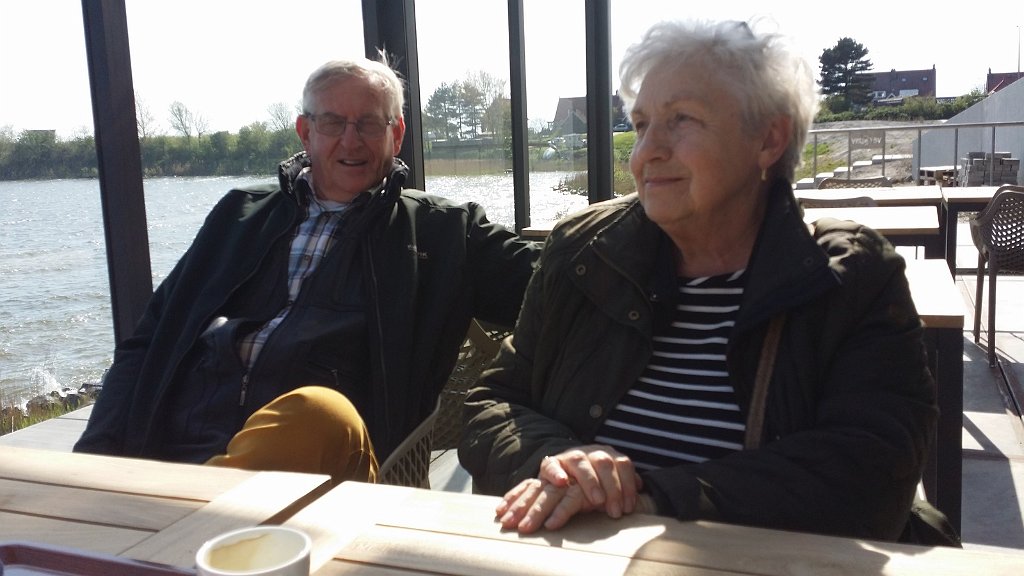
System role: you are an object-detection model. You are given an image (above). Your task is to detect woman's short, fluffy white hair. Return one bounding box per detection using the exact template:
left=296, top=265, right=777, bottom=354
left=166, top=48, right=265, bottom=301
left=618, top=20, right=818, bottom=181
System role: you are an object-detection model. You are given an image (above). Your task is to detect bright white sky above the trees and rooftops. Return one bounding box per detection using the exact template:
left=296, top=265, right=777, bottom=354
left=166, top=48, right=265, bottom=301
left=0, top=0, right=1024, bottom=137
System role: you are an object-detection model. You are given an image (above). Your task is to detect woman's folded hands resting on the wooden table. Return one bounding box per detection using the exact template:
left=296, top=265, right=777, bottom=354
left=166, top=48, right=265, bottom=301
left=495, top=445, right=649, bottom=534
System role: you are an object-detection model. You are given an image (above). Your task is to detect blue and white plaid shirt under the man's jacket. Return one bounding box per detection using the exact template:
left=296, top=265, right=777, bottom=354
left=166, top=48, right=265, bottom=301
left=239, top=170, right=348, bottom=369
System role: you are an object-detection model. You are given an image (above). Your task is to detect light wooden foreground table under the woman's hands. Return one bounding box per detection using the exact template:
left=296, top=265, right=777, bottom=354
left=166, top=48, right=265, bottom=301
left=285, top=482, right=1024, bottom=576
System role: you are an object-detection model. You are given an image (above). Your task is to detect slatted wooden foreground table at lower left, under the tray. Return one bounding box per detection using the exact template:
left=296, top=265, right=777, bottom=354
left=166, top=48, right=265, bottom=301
left=0, top=446, right=331, bottom=568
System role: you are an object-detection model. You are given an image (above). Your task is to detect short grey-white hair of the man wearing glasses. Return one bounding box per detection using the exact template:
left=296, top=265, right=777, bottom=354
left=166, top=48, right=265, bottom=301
left=302, top=51, right=406, bottom=119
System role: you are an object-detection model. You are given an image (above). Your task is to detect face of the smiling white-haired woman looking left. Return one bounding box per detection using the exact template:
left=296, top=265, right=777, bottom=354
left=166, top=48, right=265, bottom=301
left=630, top=61, right=763, bottom=234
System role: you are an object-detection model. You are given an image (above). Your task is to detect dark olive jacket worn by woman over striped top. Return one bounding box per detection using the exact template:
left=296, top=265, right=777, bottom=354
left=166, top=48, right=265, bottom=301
left=459, top=182, right=937, bottom=539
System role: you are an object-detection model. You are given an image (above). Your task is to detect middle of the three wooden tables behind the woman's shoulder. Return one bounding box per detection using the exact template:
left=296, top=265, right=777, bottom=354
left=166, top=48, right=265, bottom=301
left=804, top=205, right=945, bottom=258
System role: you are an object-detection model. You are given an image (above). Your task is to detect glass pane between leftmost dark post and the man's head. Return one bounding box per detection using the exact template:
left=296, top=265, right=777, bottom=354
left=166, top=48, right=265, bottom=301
left=126, top=0, right=365, bottom=282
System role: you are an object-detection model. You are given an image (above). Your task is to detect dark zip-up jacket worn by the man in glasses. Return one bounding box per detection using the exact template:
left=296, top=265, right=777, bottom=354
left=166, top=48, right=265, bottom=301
left=75, top=155, right=540, bottom=461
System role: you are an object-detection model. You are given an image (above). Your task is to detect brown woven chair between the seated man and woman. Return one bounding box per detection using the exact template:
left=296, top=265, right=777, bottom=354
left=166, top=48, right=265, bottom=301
left=378, top=320, right=511, bottom=489
